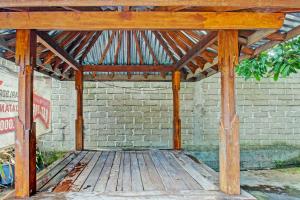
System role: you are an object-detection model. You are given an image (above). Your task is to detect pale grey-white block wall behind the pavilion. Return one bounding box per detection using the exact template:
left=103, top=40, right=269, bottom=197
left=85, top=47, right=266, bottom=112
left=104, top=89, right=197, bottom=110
left=40, top=72, right=300, bottom=149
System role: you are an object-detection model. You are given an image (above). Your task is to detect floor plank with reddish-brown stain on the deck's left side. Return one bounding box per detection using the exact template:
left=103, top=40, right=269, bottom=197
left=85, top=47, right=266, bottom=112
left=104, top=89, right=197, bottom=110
left=53, top=151, right=95, bottom=192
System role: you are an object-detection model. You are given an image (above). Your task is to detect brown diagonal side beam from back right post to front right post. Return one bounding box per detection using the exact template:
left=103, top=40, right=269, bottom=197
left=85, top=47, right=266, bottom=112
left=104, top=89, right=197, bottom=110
left=175, top=32, right=217, bottom=70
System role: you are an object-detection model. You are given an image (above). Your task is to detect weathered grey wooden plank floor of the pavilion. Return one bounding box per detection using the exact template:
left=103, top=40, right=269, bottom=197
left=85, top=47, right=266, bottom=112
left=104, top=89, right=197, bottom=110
left=7, top=150, right=254, bottom=200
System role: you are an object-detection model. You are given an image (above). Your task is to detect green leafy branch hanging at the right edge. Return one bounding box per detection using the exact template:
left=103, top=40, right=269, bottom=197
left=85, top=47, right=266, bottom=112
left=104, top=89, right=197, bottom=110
left=236, top=37, right=300, bottom=81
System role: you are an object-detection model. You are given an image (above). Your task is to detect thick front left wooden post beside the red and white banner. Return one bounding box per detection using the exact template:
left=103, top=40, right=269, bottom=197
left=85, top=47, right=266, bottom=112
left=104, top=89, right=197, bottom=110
left=15, top=30, right=36, bottom=198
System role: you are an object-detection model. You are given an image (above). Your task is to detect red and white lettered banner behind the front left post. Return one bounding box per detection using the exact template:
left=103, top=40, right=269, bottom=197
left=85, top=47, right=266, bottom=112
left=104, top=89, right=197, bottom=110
left=0, top=67, right=51, bottom=148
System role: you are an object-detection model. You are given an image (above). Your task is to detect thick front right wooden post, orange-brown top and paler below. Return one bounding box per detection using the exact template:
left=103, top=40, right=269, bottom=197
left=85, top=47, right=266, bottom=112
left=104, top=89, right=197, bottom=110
left=218, top=30, right=240, bottom=195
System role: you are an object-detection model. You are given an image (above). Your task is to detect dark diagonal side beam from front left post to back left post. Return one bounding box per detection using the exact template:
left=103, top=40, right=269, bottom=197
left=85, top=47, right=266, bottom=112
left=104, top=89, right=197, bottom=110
left=37, top=32, right=79, bottom=70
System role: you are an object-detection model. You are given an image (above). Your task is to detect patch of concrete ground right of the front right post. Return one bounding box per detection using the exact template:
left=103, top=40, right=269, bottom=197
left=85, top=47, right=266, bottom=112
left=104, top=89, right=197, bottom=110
left=241, top=167, right=300, bottom=200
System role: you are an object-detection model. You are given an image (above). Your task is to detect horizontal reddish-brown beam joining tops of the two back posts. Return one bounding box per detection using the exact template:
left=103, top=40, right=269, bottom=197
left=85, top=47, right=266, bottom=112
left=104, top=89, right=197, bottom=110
left=82, top=65, right=175, bottom=72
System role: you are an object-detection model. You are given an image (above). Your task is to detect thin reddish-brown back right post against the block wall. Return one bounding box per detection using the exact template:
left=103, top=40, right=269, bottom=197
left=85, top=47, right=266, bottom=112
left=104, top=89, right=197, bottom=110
left=172, top=71, right=181, bottom=150
